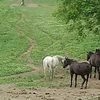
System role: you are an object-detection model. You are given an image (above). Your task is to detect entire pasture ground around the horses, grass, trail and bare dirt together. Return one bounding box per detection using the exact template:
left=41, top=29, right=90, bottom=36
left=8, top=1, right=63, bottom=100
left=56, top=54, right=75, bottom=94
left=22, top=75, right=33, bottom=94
left=0, top=0, right=100, bottom=100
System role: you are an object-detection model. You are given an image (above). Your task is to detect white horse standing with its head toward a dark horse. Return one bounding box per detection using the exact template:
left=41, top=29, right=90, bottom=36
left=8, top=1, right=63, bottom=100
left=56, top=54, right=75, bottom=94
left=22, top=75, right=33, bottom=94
left=43, top=55, right=65, bottom=79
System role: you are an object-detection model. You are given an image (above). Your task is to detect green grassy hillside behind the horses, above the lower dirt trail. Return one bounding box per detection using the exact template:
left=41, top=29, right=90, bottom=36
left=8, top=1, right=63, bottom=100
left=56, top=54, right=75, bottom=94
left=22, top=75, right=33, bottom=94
left=0, top=0, right=100, bottom=76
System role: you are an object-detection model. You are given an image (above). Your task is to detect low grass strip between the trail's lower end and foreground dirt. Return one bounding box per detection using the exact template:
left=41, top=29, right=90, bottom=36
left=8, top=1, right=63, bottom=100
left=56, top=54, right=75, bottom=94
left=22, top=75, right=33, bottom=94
left=0, top=73, right=70, bottom=88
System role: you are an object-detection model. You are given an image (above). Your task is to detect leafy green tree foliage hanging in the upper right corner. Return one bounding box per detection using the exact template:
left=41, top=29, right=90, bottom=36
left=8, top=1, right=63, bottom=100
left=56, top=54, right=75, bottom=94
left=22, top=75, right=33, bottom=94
left=54, top=0, right=100, bottom=36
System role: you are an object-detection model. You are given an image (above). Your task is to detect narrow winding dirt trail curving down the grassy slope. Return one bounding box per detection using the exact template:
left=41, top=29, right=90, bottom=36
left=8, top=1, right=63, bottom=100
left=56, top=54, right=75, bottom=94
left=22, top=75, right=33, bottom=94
left=0, top=14, right=42, bottom=78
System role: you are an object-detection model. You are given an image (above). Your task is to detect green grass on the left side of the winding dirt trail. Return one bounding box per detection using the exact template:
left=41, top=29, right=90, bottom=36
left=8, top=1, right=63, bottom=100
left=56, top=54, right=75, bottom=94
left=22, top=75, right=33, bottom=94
left=0, top=0, right=32, bottom=76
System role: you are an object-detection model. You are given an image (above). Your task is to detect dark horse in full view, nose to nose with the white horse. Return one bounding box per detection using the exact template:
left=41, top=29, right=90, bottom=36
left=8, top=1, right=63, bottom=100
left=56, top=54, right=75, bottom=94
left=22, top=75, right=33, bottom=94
left=63, top=58, right=91, bottom=89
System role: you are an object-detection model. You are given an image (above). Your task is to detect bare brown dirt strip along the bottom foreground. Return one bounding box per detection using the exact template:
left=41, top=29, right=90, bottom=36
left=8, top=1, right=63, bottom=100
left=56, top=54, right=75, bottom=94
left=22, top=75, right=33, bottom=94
left=0, top=84, right=100, bottom=100
